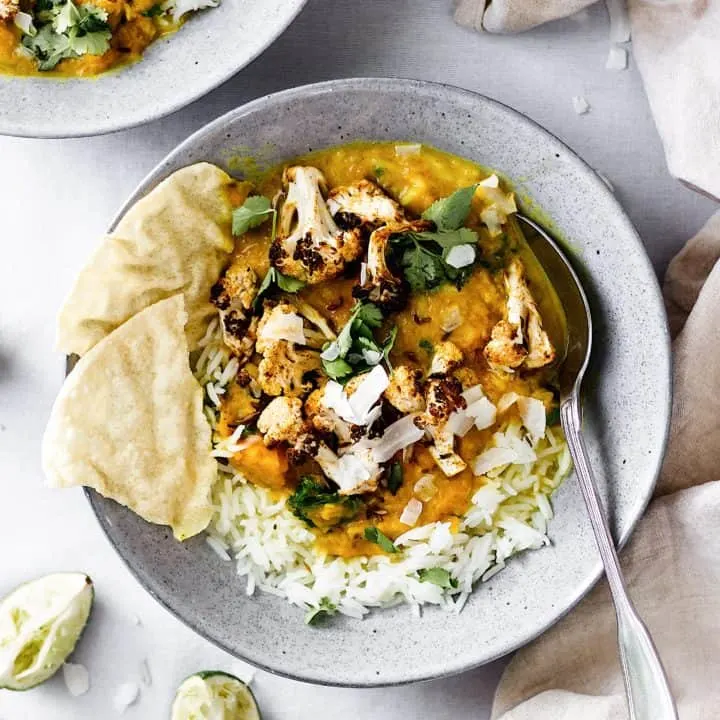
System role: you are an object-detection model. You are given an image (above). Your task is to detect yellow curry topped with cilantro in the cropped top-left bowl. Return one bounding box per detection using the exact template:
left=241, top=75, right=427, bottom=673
left=0, top=0, right=205, bottom=77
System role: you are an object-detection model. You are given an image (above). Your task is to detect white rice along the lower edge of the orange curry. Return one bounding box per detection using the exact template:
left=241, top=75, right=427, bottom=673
left=194, top=323, right=571, bottom=618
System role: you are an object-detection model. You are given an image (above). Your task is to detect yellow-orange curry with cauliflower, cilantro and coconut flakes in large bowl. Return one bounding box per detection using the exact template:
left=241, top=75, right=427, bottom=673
left=213, top=143, right=564, bottom=557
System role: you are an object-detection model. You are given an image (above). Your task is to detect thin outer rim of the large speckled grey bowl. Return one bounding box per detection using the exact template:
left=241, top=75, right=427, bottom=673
left=80, top=77, right=673, bottom=688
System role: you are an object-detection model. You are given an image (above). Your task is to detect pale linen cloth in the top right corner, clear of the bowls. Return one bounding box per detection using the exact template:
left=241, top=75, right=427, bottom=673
left=455, top=0, right=720, bottom=198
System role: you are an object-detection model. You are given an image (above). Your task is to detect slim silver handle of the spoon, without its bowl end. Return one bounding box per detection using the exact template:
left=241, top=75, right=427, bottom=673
left=560, top=393, right=678, bottom=720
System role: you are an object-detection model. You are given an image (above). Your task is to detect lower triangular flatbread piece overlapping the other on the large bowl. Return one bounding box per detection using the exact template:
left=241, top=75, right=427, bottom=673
left=42, top=295, right=217, bottom=540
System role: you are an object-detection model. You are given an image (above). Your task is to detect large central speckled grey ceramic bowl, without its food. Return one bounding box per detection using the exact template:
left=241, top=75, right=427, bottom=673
left=88, top=79, right=670, bottom=686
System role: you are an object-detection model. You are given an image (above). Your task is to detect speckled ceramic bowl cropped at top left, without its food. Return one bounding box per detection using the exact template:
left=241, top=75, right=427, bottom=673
left=0, top=0, right=307, bottom=138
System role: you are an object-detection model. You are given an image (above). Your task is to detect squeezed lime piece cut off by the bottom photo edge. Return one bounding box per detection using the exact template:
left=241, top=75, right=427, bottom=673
left=172, top=670, right=260, bottom=720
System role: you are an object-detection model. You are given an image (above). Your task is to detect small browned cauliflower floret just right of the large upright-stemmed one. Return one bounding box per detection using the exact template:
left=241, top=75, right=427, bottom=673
left=327, top=180, right=405, bottom=230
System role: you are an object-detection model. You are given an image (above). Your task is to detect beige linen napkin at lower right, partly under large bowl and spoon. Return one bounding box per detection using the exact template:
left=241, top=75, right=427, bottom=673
left=493, top=213, right=720, bottom=720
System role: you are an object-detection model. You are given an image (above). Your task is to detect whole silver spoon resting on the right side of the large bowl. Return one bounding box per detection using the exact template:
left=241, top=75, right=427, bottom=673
left=516, top=215, right=677, bottom=720
